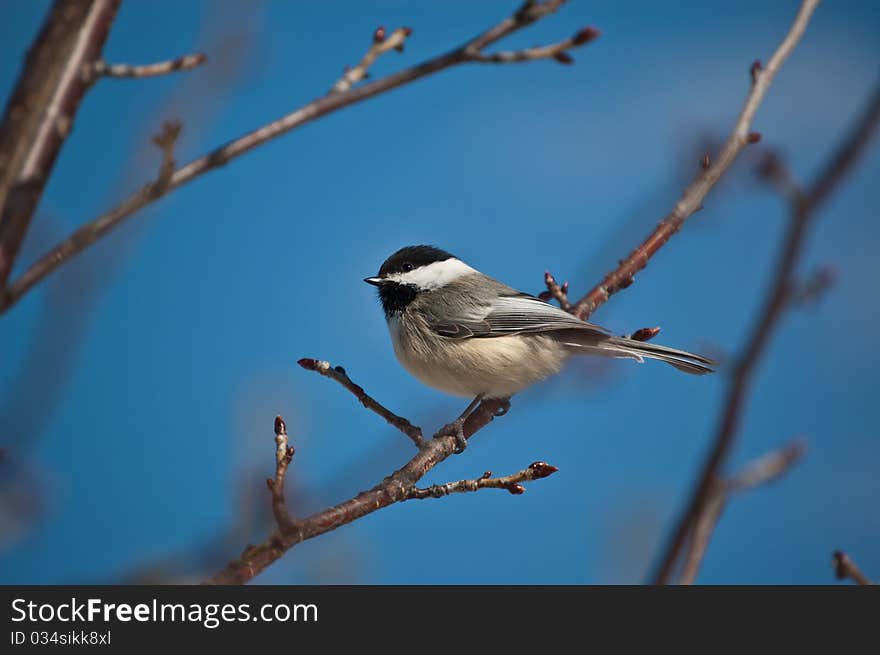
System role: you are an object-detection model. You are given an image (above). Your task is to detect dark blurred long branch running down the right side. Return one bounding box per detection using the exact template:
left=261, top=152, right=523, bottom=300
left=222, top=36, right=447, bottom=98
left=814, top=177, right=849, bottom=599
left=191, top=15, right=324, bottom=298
left=652, top=77, right=880, bottom=584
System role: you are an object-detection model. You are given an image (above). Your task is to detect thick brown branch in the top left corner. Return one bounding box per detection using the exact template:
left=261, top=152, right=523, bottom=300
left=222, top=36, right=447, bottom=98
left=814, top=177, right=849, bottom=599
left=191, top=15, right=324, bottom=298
left=0, top=0, right=120, bottom=289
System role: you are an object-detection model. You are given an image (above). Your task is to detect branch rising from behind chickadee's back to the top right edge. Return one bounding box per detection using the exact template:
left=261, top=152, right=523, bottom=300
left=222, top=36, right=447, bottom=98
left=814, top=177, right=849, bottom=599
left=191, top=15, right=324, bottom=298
left=573, top=0, right=819, bottom=320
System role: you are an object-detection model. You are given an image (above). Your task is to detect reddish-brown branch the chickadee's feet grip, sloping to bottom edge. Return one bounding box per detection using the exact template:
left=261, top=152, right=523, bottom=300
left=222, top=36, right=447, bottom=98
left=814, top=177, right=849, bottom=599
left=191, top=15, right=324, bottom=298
left=209, top=392, right=503, bottom=584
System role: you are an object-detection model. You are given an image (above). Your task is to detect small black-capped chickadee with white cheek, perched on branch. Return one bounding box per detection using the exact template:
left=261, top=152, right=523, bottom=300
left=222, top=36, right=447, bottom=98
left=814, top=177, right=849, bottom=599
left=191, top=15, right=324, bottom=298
left=364, top=246, right=713, bottom=447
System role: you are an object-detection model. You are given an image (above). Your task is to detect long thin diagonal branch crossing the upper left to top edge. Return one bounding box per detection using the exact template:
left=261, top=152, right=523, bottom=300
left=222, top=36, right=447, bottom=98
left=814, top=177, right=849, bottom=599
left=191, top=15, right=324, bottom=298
left=0, top=0, right=600, bottom=312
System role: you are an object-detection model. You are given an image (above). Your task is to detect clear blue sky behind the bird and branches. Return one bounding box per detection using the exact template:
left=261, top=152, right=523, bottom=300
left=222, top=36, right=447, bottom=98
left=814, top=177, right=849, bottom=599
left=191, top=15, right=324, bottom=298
left=0, top=0, right=880, bottom=584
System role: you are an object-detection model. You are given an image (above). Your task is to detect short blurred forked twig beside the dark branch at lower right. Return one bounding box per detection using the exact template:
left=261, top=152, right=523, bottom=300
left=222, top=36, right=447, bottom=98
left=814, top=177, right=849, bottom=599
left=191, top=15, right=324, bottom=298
left=679, top=441, right=805, bottom=584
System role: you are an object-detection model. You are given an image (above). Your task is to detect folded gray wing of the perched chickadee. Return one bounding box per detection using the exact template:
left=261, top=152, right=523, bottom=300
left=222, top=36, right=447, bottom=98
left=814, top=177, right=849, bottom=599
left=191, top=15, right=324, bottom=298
left=428, top=290, right=608, bottom=339
